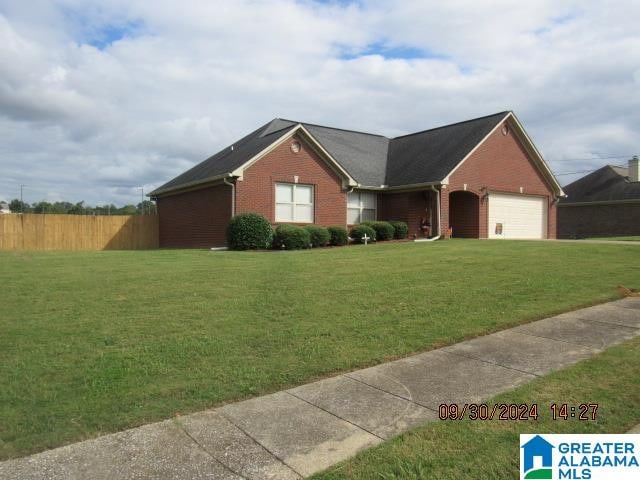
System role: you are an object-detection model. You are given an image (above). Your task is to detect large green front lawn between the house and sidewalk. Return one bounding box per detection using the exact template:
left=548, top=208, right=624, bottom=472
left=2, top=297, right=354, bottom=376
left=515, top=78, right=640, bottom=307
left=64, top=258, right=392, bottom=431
left=0, top=240, right=640, bottom=459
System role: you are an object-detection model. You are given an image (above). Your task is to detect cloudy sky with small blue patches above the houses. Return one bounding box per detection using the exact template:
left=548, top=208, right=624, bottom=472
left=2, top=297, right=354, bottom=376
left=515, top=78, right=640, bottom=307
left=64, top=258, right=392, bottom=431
left=0, top=0, right=640, bottom=204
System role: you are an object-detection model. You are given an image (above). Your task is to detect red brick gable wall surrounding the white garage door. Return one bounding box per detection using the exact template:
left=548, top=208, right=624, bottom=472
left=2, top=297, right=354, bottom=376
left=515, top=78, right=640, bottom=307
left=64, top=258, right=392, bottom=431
left=442, top=122, right=556, bottom=238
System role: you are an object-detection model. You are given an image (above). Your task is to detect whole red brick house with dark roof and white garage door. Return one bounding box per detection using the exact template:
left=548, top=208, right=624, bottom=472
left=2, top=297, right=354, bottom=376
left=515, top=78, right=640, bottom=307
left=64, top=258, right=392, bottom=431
left=151, top=112, right=564, bottom=248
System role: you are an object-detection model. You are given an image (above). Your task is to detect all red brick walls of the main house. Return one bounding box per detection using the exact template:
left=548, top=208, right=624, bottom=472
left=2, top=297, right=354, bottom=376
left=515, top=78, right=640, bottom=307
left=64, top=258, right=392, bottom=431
left=158, top=120, right=556, bottom=247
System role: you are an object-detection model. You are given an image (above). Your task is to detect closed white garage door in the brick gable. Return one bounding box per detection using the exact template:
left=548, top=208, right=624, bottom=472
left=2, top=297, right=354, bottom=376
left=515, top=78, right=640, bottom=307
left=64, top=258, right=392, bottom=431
left=489, top=193, right=547, bottom=238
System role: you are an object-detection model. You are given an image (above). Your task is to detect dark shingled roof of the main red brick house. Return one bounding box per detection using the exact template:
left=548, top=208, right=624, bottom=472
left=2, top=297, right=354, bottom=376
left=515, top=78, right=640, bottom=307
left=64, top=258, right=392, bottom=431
left=150, top=111, right=561, bottom=196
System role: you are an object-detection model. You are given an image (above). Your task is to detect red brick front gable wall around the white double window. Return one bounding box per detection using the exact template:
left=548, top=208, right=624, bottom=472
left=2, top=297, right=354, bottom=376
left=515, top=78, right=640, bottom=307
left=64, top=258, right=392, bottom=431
left=236, top=137, right=347, bottom=226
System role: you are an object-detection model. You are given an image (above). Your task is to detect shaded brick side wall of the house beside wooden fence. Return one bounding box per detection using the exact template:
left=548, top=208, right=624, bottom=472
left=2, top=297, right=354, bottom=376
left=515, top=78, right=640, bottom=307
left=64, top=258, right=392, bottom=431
left=157, top=184, right=231, bottom=248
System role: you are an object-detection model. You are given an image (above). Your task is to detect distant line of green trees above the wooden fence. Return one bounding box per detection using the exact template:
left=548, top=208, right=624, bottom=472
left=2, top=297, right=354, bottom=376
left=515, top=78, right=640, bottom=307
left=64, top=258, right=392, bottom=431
left=2, top=198, right=158, bottom=215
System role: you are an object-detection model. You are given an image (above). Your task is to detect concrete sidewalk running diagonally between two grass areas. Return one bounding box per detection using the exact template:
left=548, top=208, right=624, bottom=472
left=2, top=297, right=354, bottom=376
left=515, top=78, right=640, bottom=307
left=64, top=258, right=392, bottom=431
left=0, top=298, right=640, bottom=480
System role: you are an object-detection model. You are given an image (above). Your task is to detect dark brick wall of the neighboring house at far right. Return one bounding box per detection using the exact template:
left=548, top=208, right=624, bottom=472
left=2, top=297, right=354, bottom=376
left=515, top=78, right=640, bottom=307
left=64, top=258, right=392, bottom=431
left=558, top=200, right=640, bottom=238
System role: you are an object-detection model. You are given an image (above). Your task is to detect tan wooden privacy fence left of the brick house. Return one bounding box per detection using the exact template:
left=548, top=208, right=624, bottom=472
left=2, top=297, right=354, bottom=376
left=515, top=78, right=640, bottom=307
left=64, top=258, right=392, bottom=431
left=0, top=213, right=158, bottom=250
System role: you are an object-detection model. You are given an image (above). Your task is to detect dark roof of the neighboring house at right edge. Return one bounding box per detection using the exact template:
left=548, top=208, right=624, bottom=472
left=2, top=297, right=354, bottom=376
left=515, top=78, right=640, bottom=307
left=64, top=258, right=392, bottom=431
left=561, top=165, right=640, bottom=204
